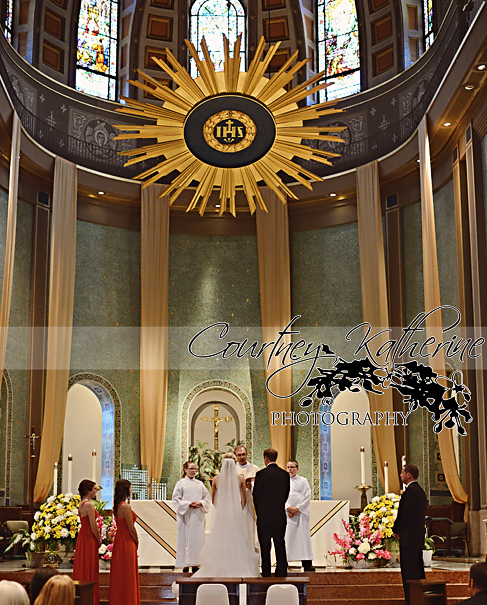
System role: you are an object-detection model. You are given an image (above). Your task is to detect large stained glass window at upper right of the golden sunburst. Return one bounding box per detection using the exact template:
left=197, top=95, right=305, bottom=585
left=318, top=0, right=360, bottom=101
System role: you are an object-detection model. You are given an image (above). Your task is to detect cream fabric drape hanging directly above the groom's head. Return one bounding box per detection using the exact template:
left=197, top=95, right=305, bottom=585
left=256, top=188, right=292, bottom=468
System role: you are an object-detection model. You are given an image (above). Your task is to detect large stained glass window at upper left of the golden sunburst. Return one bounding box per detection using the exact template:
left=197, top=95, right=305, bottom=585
left=76, top=0, right=118, bottom=101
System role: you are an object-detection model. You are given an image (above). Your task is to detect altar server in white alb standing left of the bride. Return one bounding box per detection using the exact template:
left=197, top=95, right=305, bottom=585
left=172, top=461, right=211, bottom=572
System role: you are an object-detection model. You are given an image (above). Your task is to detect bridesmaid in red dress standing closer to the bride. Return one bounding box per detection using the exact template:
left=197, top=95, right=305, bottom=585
left=109, top=479, right=140, bottom=605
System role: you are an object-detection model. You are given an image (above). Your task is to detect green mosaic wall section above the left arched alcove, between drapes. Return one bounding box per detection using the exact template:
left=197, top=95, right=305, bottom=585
left=71, top=221, right=140, bottom=464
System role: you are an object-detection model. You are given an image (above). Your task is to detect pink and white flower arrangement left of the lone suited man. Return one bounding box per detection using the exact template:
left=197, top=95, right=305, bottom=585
left=328, top=513, right=391, bottom=563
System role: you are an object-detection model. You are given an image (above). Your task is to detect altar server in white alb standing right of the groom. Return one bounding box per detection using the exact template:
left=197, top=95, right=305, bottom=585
left=285, top=460, right=315, bottom=571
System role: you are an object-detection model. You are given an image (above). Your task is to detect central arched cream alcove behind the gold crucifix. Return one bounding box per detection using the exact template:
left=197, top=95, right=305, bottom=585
left=181, top=380, right=253, bottom=462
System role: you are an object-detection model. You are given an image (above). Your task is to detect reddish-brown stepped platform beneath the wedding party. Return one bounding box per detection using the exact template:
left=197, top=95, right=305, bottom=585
left=0, top=561, right=470, bottom=605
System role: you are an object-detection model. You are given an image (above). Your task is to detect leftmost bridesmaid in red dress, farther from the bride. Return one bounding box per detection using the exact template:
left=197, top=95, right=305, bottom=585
left=73, top=479, right=100, bottom=605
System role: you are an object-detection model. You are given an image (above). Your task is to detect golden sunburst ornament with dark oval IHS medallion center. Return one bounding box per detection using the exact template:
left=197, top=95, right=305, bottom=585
left=116, top=36, right=345, bottom=216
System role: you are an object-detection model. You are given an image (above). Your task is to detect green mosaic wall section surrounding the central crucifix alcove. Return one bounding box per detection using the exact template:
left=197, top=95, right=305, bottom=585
left=163, top=235, right=270, bottom=492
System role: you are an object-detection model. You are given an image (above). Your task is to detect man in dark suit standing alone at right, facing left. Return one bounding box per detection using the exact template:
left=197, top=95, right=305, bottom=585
left=393, top=464, right=427, bottom=605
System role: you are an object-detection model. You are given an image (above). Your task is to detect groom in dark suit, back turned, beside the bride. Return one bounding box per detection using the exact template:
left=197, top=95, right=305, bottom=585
left=252, top=449, right=291, bottom=578
